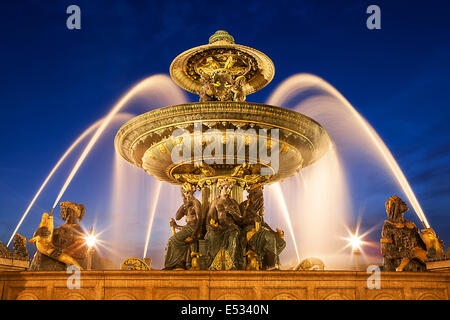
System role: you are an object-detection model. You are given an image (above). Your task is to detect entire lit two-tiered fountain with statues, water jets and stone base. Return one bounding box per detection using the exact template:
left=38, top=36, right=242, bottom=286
left=0, top=31, right=448, bottom=299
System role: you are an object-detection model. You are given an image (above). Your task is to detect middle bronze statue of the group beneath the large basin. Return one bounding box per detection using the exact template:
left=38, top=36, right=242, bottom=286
left=205, top=179, right=243, bottom=270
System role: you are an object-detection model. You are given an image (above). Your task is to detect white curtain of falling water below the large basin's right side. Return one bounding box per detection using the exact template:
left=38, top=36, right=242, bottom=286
left=266, top=148, right=351, bottom=269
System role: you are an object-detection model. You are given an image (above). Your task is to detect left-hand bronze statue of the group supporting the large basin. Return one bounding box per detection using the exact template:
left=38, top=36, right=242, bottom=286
left=164, top=183, right=203, bottom=270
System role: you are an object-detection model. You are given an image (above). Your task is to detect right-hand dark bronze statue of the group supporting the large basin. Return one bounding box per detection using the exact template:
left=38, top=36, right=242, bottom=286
left=240, top=185, right=286, bottom=270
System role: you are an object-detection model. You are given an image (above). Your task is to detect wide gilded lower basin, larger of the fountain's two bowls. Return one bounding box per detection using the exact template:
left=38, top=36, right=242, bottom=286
left=115, top=101, right=331, bottom=186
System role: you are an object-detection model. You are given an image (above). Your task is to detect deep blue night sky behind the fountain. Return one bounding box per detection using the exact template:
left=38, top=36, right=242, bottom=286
left=0, top=0, right=450, bottom=262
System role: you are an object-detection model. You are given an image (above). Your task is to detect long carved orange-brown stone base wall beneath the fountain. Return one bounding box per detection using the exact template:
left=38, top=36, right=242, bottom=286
left=0, top=271, right=450, bottom=300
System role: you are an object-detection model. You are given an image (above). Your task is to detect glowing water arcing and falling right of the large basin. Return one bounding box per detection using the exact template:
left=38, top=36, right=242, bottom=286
left=267, top=74, right=429, bottom=269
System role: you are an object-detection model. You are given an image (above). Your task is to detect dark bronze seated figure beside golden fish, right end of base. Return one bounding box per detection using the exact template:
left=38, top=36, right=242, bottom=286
left=380, top=196, right=426, bottom=271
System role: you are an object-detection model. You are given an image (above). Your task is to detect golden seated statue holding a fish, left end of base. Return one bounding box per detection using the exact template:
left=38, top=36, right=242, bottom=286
left=29, top=201, right=87, bottom=271
